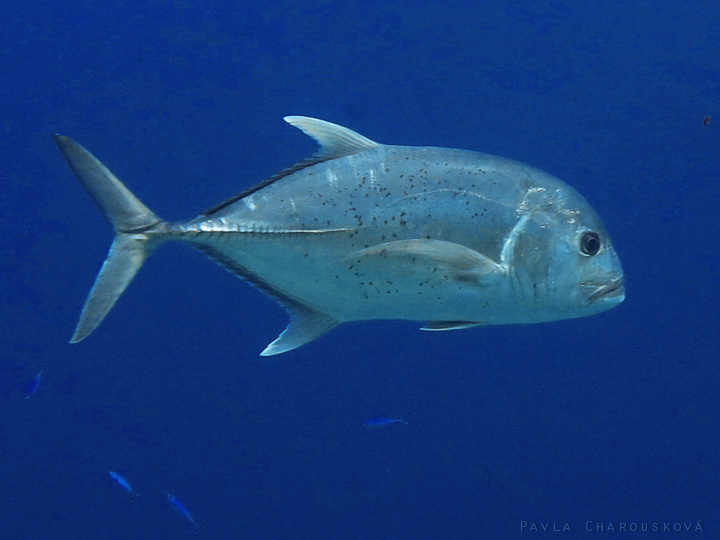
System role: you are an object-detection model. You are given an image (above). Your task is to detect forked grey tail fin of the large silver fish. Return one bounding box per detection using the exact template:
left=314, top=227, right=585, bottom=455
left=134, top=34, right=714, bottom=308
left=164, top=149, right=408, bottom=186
left=54, top=135, right=166, bottom=343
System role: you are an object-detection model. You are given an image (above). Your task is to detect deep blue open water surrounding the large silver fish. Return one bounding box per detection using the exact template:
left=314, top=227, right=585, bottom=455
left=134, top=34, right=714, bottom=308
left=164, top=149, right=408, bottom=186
left=0, top=0, right=720, bottom=539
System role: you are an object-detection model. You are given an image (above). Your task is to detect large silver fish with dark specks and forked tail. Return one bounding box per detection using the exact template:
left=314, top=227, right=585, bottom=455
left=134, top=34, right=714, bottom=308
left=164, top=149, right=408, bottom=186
left=55, top=116, right=625, bottom=356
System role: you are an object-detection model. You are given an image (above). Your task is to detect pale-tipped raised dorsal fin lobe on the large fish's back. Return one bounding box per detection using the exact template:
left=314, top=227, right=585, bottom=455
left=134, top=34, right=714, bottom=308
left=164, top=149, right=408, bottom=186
left=283, top=116, right=380, bottom=160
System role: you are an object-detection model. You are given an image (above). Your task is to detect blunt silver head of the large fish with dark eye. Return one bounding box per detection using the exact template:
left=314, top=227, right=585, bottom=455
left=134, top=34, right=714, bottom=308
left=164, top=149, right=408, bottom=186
left=511, top=184, right=625, bottom=322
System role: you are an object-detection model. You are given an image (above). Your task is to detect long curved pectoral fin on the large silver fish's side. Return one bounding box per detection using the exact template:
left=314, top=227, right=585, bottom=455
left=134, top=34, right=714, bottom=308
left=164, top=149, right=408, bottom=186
left=350, top=238, right=504, bottom=285
